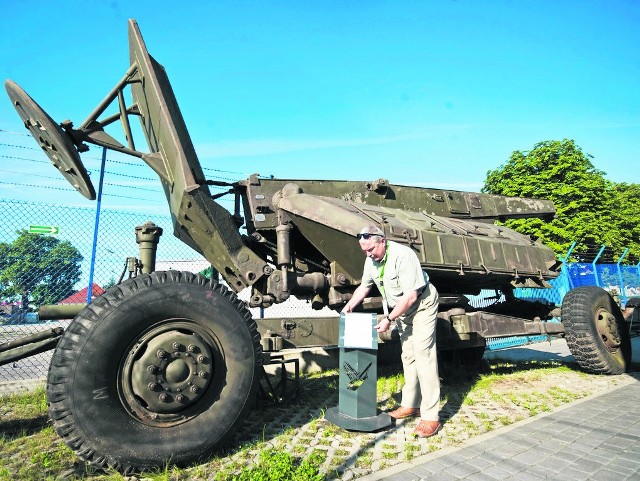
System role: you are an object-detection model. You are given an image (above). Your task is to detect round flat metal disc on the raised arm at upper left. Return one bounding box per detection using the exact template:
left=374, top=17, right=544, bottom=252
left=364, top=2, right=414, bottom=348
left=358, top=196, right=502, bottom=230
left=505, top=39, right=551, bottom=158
left=4, top=80, right=96, bottom=200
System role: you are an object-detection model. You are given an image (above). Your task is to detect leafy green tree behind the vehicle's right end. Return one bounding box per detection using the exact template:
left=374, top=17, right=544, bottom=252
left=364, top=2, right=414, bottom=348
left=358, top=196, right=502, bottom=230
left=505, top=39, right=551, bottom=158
left=482, top=139, right=640, bottom=262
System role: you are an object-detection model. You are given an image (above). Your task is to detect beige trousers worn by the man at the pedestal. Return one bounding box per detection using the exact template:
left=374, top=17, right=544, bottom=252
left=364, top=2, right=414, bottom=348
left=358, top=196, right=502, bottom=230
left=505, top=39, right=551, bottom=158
left=397, top=284, right=440, bottom=421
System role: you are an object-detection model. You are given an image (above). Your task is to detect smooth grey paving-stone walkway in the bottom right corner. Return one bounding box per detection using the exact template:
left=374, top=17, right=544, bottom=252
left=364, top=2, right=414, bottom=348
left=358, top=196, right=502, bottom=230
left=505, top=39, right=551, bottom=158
left=358, top=338, right=640, bottom=481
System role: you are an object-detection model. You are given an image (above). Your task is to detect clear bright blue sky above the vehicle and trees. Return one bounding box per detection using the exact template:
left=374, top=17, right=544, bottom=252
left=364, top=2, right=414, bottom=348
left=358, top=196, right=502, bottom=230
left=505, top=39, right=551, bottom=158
left=0, top=0, right=640, bottom=214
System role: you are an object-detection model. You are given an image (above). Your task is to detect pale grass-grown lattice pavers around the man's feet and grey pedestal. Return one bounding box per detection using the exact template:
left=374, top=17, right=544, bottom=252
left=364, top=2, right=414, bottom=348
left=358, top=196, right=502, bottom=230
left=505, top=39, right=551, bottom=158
left=196, top=361, right=633, bottom=480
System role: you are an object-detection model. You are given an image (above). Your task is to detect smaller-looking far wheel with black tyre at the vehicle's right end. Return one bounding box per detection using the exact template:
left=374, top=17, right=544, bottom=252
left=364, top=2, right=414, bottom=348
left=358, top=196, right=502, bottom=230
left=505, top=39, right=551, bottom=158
left=561, top=286, right=631, bottom=374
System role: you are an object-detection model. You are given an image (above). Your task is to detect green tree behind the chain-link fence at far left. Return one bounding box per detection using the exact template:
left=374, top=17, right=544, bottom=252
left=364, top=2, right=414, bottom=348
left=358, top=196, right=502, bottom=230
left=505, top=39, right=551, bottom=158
left=0, top=230, right=83, bottom=310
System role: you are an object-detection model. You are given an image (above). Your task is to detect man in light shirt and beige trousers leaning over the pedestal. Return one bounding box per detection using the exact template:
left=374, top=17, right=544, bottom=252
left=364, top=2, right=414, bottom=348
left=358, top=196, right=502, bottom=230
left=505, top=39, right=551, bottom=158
left=342, top=226, right=442, bottom=437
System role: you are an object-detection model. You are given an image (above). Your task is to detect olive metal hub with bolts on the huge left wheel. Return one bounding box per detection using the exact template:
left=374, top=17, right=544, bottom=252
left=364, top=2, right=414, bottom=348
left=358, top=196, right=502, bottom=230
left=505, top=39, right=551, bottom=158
left=131, top=330, right=213, bottom=414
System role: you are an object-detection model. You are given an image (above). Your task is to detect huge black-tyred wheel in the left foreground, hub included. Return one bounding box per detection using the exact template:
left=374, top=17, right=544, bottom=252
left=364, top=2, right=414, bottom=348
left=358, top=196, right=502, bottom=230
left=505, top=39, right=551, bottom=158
left=47, top=271, right=261, bottom=473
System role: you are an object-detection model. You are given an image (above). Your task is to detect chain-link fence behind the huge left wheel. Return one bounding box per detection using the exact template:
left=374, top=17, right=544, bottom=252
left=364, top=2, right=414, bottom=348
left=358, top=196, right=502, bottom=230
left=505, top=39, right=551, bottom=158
left=0, top=199, right=336, bottom=394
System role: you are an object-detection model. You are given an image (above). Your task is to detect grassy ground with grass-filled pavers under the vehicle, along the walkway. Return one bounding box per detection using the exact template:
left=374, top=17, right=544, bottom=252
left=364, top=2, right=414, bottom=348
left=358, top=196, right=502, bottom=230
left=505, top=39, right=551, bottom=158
left=0, top=361, right=632, bottom=481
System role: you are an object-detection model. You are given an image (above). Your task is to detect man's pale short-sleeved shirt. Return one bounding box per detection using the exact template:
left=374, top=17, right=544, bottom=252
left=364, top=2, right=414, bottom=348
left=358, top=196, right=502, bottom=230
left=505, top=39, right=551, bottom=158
left=362, top=241, right=429, bottom=308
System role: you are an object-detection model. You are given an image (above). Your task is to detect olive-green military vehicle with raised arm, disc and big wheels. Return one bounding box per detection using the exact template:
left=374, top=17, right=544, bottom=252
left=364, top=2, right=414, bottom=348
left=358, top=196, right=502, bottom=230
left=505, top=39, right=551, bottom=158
left=5, top=20, right=631, bottom=472
